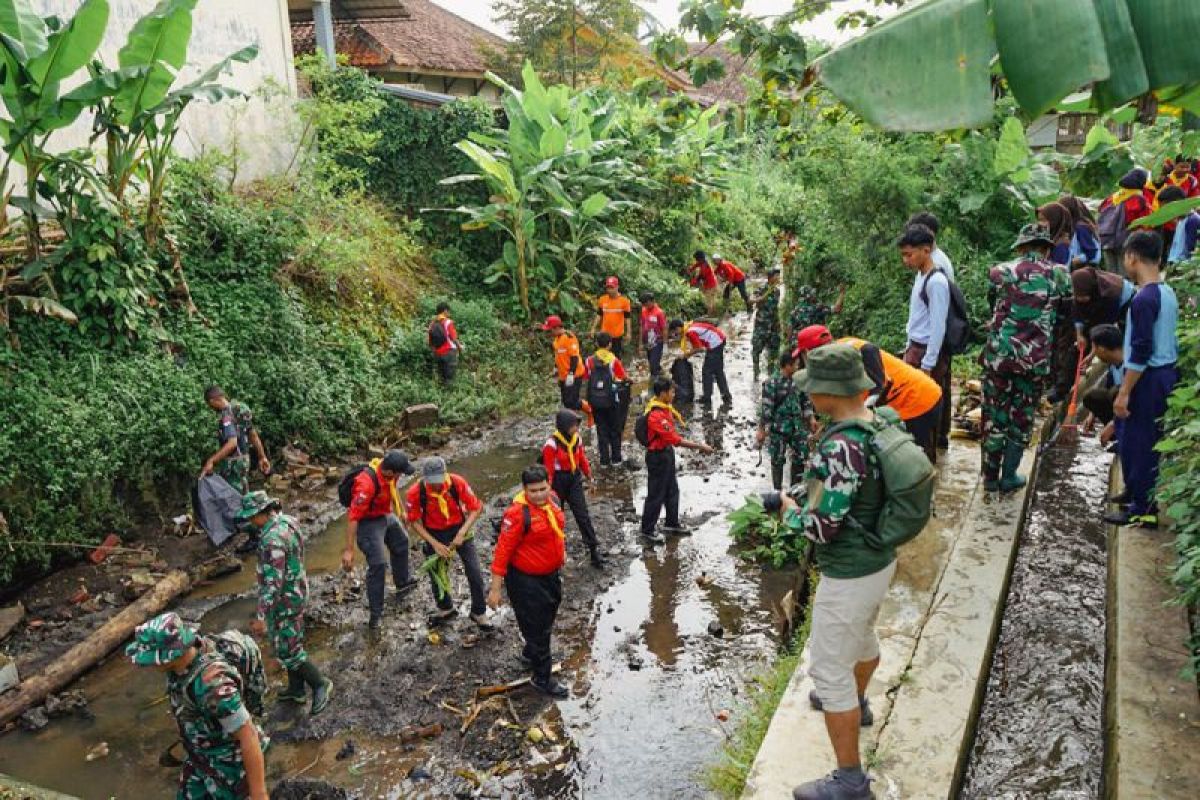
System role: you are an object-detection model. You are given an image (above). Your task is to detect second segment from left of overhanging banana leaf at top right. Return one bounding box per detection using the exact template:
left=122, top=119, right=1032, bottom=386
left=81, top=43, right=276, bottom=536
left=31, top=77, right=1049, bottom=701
left=991, top=0, right=1109, bottom=116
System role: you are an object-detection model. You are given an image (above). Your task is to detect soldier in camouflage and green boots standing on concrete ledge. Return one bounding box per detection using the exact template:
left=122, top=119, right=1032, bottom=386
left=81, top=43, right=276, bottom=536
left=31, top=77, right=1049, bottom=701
left=979, top=224, right=1070, bottom=492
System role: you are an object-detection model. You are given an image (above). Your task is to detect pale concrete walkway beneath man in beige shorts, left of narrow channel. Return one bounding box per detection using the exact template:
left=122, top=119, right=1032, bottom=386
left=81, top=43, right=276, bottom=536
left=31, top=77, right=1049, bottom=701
left=743, top=440, right=1033, bottom=800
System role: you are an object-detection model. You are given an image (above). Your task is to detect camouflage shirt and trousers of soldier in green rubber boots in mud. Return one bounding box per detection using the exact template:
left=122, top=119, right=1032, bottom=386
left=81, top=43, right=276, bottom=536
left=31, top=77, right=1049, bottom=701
left=258, top=513, right=308, bottom=672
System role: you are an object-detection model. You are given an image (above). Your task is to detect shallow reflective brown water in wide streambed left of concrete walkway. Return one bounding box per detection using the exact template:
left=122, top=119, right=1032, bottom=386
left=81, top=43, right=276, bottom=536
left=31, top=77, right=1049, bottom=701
left=0, top=314, right=793, bottom=800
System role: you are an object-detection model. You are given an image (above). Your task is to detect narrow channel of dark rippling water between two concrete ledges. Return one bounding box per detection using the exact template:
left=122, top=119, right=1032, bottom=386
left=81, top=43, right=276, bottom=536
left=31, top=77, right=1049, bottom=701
left=959, top=439, right=1108, bottom=800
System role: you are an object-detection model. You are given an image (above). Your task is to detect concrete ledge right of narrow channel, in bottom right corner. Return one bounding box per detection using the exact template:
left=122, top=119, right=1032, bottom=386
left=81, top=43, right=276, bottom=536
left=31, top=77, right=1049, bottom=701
left=1105, top=515, right=1200, bottom=800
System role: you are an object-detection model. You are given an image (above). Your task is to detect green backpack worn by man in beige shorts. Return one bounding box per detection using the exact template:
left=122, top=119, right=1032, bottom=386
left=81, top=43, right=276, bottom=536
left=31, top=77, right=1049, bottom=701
left=822, top=407, right=934, bottom=549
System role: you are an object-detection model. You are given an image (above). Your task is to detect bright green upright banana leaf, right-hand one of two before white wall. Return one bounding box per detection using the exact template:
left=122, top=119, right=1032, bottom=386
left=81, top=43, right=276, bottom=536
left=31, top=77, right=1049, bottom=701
left=113, top=0, right=197, bottom=125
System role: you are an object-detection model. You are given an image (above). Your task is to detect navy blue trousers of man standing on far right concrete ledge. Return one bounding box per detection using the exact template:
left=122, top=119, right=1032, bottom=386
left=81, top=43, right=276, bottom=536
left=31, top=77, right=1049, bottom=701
left=1116, top=365, right=1180, bottom=515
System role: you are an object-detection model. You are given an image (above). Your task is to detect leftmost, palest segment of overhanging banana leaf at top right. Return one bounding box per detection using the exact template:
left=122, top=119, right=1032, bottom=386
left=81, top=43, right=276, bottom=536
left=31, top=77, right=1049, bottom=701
left=815, top=0, right=993, bottom=131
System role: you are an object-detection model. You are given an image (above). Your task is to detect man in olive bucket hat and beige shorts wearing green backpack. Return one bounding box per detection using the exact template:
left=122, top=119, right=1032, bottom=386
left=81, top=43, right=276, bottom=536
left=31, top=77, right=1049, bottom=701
left=781, top=344, right=934, bottom=800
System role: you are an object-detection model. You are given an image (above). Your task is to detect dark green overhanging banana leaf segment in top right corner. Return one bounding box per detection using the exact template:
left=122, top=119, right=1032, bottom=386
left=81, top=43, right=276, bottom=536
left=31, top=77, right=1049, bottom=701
left=1129, top=0, right=1200, bottom=89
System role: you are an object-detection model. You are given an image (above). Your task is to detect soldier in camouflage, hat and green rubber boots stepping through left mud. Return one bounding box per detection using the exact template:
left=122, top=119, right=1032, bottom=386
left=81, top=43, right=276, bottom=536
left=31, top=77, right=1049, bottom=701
left=238, top=492, right=334, bottom=716
